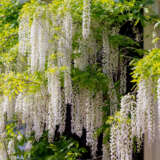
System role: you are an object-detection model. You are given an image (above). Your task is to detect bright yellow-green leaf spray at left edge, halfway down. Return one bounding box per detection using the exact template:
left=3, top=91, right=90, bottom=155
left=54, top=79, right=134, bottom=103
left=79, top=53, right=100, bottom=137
left=0, top=72, right=44, bottom=97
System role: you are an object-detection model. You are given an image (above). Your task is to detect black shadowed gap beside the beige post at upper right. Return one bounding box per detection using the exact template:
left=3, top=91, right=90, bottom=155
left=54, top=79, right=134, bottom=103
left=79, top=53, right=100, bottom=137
left=119, top=21, right=144, bottom=93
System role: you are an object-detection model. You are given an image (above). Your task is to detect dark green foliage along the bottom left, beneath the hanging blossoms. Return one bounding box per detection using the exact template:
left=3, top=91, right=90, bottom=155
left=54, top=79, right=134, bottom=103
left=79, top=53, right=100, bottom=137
left=6, top=122, right=86, bottom=160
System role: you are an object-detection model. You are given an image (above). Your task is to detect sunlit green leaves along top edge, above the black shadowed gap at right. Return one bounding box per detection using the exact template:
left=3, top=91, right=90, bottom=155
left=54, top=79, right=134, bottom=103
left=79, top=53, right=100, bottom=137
left=92, top=0, right=148, bottom=25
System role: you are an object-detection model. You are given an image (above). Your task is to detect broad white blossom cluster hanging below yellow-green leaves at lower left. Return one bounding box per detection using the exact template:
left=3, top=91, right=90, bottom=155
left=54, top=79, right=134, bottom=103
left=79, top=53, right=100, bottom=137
left=15, top=91, right=48, bottom=140
